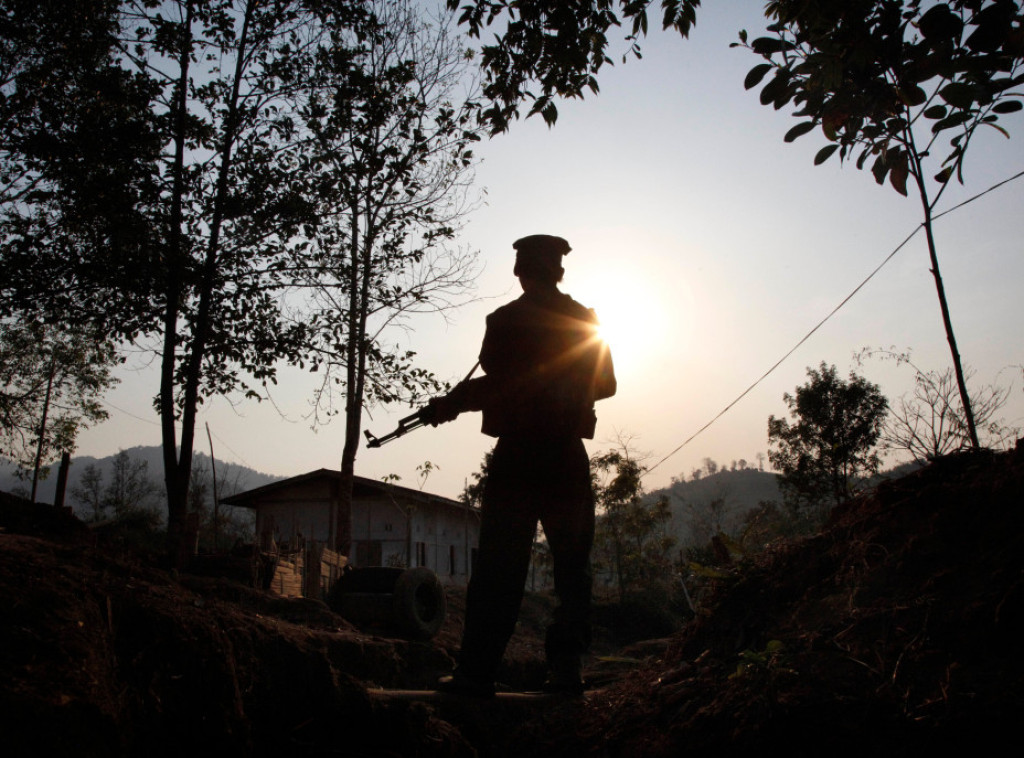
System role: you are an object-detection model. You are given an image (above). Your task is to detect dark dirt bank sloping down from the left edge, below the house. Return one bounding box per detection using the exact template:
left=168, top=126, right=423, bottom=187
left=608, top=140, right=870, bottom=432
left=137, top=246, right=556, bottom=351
left=0, top=502, right=464, bottom=756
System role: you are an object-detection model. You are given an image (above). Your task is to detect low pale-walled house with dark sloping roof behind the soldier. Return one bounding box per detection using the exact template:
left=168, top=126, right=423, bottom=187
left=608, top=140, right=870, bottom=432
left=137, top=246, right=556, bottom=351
left=221, top=468, right=480, bottom=597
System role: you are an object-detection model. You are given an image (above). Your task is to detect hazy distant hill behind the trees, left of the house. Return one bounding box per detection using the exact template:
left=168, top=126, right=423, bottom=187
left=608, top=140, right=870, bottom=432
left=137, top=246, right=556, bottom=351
left=0, top=446, right=285, bottom=515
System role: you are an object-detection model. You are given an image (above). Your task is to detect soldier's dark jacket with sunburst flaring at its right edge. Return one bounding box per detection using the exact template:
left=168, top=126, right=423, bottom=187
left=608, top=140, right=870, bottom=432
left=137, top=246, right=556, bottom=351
left=455, top=292, right=615, bottom=439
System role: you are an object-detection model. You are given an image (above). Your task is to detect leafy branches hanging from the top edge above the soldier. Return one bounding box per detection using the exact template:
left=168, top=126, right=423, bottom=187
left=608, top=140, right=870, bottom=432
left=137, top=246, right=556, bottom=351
left=447, top=0, right=700, bottom=132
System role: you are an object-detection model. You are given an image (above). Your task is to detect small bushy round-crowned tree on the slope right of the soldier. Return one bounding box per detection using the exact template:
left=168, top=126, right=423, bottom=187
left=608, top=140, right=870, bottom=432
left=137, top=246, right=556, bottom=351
left=768, top=363, right=888, bottom=515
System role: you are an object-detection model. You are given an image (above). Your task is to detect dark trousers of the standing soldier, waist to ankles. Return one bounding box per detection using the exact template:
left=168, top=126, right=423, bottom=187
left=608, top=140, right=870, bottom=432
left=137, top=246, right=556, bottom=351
left=459, top=437, right=594, bottom=681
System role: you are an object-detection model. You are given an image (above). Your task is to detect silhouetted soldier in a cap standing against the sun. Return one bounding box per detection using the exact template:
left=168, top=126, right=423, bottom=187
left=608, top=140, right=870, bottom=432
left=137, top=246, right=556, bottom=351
left=428, top=235, right=615, bottom=697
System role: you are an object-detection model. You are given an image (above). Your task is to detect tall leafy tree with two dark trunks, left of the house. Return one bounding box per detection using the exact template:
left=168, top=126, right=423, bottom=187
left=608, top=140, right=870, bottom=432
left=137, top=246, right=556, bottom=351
left=115, top=0, right=361, bottom=562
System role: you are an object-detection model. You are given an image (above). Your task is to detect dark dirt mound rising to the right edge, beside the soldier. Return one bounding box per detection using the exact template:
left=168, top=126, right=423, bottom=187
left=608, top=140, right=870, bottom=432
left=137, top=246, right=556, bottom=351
left=509, top=445, right=1024, bottom=757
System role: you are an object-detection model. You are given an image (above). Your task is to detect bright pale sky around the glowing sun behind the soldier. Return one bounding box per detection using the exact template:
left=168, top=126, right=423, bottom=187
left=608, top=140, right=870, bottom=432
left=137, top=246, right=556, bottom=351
left=78, top=0, right=1024, bottom=497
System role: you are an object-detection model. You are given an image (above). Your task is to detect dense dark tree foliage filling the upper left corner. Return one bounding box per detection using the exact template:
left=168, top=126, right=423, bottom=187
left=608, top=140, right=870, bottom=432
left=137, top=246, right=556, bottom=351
left=0, top=0, right=159, bottom=338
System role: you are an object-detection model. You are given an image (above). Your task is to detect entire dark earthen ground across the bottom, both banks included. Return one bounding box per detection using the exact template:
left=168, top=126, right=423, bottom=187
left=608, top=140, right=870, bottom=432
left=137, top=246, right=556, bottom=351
left=0, top=446, right=1024, bottom=758
